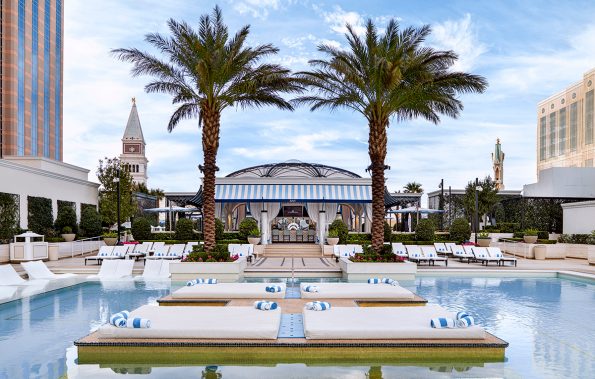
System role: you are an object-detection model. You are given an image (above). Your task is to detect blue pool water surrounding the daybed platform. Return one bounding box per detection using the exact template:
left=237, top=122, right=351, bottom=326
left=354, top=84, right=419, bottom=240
left=0, top=277, right=595, bottom=379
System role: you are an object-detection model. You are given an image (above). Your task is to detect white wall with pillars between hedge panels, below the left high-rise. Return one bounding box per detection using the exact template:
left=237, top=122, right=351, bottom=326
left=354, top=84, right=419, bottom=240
left=0, top=158, right=99, bottom=229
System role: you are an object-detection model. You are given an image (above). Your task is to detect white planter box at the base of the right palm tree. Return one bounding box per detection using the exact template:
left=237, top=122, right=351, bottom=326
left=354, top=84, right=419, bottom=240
left=339, top=258, right=417, bottom=281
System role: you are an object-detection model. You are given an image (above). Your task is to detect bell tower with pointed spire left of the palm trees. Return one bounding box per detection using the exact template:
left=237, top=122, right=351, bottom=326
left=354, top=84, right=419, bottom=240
left=120, top=97, right=149, bottom=185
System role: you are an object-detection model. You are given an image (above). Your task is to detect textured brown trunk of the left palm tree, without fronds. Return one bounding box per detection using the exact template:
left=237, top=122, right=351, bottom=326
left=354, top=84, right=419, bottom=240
left=202, top=109, right=221, bottom=251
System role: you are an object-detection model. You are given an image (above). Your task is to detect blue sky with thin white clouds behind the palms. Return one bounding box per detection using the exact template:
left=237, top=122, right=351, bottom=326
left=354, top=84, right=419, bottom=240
left=64, top=0, right=595, bottom=196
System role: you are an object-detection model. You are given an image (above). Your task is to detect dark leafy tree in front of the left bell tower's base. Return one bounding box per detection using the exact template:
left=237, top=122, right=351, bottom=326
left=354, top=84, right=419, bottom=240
left=97, top=157, right=136, bottom=226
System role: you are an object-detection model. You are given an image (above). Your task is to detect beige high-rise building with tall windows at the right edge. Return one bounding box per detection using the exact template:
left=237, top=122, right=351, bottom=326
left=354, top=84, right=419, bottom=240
left=537, top=69, right=595, bottom=178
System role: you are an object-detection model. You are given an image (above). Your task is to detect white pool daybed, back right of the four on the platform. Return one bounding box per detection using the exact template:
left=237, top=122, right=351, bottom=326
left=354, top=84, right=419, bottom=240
left=300, top=283, right=414, bottom=300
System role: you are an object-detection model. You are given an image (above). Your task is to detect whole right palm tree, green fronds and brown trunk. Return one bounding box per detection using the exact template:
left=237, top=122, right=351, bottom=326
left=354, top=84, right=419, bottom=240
left=295, top=20, right=487, bottom=252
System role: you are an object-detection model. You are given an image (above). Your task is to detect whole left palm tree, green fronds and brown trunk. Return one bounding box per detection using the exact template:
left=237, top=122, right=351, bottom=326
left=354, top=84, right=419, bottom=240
left=112, top=6, right=302, bottom=251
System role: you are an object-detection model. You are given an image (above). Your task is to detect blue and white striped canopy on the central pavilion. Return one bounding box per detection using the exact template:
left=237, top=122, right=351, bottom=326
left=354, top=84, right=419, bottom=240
left=215, top=184, right=372, bottom=203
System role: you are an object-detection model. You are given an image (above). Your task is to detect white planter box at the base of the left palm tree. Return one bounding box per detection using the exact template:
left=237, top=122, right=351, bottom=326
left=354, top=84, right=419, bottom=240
left=169, top=258, right=246, bottom=282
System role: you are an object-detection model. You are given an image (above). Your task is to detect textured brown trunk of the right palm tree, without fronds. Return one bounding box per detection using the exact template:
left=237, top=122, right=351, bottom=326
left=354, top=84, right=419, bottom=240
left=368, top=121, right=388, bottom=253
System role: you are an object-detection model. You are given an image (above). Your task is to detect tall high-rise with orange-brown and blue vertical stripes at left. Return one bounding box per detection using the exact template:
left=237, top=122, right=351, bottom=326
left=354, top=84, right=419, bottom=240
left=0, top=0, right=64, bottom=161
